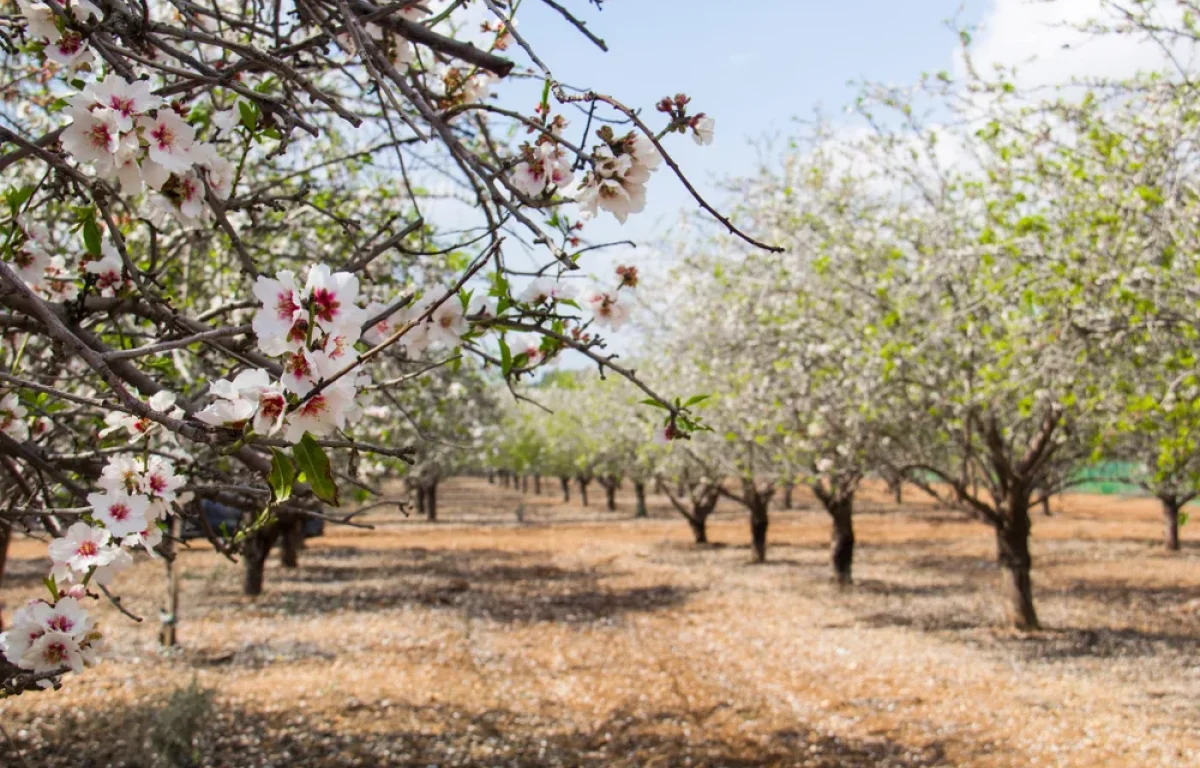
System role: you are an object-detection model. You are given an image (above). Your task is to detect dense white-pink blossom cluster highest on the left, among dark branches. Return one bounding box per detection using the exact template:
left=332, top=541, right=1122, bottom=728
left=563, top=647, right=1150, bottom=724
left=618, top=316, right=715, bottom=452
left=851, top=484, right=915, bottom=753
left=62, top=74, right=234, bottom=226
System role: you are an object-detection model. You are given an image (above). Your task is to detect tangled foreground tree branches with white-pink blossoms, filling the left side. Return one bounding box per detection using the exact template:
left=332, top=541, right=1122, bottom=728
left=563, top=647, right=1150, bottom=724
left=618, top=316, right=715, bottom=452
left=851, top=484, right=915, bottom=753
left=0, top=0, right=777, bottom=680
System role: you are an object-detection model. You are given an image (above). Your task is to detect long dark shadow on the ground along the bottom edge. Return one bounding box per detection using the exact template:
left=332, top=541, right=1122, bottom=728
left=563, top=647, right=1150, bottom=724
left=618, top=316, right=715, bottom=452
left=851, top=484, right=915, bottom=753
left=7, top=695, right=964, bottom=768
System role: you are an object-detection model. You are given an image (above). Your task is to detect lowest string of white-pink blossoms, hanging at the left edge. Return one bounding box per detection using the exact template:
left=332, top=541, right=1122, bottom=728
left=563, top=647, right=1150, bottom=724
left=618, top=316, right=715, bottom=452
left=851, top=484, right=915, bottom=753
left=0, top=455, right=187, bottom=683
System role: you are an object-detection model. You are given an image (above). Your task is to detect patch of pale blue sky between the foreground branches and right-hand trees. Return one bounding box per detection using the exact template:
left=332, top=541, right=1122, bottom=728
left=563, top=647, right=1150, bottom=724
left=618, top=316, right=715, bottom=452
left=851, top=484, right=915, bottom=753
left=501, top=0, right=992, bottom=249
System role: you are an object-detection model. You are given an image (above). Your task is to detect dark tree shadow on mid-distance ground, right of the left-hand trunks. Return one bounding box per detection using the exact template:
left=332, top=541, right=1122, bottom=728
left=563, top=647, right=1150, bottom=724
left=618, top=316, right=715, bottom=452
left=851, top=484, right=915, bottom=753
left=202, top=547, right=694, bottom=624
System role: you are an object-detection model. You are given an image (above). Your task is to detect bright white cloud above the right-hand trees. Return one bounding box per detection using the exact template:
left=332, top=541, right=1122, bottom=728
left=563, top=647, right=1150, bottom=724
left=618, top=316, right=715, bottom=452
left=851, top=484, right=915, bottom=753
left=955, top=0, right=1190, bottom=86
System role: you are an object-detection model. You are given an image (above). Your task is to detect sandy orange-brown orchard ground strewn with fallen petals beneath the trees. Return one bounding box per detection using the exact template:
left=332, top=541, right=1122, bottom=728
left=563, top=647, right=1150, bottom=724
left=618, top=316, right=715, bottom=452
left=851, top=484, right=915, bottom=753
left=0, top=479, right=1200, bottom=768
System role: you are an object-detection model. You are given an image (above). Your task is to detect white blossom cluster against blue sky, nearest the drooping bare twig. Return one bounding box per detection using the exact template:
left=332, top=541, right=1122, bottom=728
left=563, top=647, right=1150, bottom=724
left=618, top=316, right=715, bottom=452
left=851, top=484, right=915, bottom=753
left=576, top=126, right=662, bottom=223
